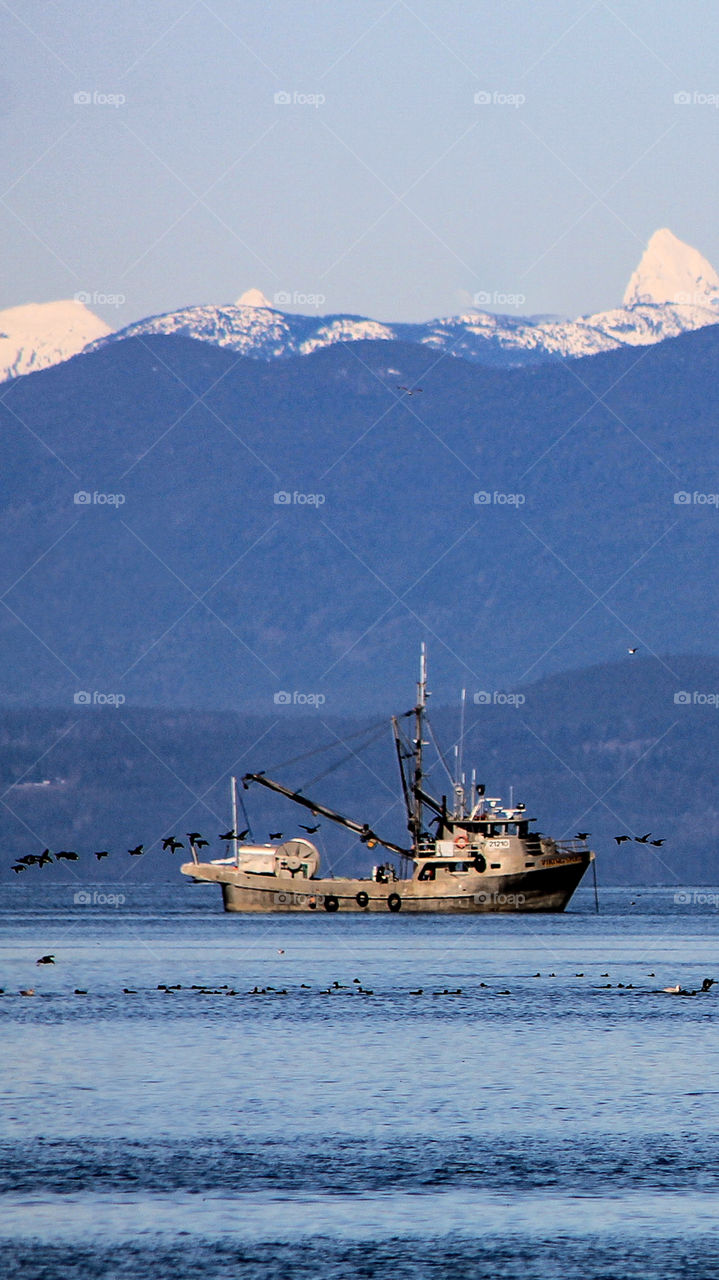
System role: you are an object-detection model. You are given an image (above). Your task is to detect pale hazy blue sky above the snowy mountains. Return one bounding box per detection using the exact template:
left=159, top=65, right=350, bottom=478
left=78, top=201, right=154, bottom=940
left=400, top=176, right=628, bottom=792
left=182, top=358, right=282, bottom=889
left=0, top=0, right=719, bottom=325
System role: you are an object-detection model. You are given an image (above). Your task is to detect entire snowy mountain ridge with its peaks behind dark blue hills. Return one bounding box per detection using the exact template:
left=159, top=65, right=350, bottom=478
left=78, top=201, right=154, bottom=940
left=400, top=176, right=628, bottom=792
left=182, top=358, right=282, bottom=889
left=0, top=228, right=719, bottom=380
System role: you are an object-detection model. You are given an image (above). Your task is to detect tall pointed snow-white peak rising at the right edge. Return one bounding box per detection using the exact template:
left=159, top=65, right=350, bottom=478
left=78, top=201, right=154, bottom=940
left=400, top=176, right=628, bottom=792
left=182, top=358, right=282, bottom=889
left=624, top=227, right=719, bottom=308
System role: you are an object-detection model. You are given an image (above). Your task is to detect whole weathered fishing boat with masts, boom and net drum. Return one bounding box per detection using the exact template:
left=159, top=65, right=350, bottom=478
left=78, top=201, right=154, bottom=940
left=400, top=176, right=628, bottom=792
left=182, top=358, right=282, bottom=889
left=180, top=646, right=595, bottom=915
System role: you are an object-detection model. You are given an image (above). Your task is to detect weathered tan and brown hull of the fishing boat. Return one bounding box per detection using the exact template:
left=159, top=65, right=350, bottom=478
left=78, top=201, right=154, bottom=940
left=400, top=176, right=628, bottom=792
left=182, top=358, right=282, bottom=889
left=182, top=851, right=592, bottom=915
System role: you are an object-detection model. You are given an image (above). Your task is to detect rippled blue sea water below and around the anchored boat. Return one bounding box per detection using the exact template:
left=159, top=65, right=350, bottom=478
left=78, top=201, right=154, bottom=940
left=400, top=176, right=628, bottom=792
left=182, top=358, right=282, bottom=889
left=0, top=881, right=719, bottom=1280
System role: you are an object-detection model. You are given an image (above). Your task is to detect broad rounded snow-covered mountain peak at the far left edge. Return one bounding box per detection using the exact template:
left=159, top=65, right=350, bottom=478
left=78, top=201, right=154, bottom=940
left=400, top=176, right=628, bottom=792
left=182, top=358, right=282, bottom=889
left=0, top=298, right=113, bottom=381
